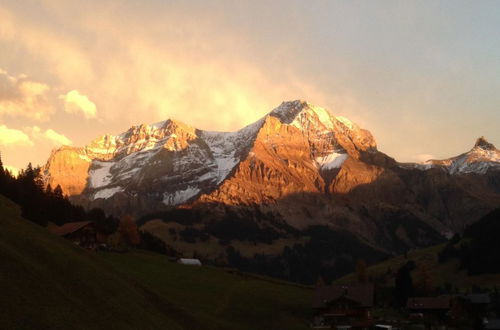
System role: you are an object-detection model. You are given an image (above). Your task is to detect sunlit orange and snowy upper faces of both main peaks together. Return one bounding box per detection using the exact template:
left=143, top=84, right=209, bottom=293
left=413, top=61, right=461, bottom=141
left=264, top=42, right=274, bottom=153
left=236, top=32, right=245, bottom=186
left=44, top=101, right=376, bottom=213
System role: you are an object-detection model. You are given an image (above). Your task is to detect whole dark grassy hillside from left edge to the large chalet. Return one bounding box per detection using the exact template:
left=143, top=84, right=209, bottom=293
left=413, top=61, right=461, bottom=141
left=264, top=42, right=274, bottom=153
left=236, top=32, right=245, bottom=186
left=0, top=196, right=312, bottom=329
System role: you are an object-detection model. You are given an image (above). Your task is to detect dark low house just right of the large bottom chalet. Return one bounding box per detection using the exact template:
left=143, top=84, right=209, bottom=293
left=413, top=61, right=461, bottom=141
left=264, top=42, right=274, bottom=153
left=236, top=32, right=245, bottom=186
left=406, top=295, right=452, bottom=323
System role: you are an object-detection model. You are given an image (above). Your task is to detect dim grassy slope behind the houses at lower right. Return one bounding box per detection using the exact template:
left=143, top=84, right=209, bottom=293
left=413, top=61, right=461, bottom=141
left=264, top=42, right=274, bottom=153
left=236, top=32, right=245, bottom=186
left=337, top=244, right=500, bottom=289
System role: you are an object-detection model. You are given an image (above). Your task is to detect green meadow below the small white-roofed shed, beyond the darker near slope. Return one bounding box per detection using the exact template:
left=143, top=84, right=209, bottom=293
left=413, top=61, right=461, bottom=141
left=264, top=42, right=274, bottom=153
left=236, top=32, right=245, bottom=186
left=100, top=254, right=312, bottom=329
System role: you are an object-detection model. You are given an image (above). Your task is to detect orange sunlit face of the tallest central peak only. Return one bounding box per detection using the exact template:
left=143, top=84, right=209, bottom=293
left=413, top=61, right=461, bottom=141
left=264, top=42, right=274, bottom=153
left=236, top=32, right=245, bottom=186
left=199, top=101, right=376, bottom=205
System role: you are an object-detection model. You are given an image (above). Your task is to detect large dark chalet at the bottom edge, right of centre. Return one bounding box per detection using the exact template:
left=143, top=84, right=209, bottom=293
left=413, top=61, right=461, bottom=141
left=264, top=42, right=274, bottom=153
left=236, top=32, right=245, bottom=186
left=312, top=284, right=374, bottom=329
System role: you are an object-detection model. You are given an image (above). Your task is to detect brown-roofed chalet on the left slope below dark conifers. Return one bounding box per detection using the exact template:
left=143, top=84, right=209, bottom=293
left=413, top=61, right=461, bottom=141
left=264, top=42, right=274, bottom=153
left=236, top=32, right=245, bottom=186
left=50, top=221, right=101, bottom=250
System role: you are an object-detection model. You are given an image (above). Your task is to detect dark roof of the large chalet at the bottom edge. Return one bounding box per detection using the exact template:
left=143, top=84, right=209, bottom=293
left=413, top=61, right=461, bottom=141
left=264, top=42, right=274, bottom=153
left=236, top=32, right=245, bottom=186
left=313, top=283, right=373, bottom=308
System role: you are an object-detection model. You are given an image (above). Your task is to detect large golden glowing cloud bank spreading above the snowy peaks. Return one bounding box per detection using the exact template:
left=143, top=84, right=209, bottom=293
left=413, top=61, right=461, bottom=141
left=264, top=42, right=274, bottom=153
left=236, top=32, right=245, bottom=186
left=0, top=2, right=335, bottom=130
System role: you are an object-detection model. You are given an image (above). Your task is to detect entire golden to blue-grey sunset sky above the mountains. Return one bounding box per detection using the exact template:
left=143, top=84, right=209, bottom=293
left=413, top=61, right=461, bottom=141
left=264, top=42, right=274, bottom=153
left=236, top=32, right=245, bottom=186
left=0, top=0, right=500, bottom=173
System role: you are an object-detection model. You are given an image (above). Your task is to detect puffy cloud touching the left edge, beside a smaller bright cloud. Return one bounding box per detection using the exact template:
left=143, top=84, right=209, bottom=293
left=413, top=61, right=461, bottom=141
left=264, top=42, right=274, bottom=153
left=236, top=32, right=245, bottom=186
left=0, top=69, right=55, bottom=121
